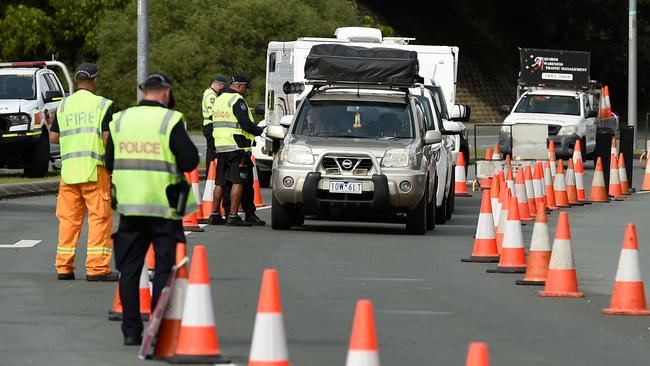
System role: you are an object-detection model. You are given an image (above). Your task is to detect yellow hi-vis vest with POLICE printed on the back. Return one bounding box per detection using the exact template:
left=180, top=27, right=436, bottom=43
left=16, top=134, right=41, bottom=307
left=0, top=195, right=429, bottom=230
left=109, top=106, right=197, bottom=220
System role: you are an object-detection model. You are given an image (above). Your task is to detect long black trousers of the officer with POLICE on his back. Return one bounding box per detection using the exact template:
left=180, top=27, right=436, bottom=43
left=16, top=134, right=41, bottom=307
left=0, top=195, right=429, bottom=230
left=113, top=215, right=185, bottom=336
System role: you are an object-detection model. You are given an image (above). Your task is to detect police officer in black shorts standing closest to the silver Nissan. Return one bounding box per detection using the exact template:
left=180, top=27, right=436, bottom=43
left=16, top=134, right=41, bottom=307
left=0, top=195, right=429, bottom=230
left=208, top=75, right=266, bottom=226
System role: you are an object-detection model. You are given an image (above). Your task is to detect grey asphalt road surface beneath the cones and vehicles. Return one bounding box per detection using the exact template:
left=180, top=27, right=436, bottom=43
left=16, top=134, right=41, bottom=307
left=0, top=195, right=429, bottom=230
left=0, top=164, right=650, bottom=366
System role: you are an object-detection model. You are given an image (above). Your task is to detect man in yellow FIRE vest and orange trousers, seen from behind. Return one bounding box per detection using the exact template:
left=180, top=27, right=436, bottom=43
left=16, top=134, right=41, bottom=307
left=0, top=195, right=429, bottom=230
left=50, top=64, right=118, bottom=281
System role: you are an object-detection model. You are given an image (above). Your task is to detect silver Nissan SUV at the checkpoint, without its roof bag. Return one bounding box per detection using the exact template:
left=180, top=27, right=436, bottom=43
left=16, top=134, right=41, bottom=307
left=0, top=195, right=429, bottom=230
left=267, top=84, right=442, bottom=234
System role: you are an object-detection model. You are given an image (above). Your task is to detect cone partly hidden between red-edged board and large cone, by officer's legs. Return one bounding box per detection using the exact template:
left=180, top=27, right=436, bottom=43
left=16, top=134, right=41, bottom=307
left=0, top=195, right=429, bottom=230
left=153, top=243, right=188, bottom=359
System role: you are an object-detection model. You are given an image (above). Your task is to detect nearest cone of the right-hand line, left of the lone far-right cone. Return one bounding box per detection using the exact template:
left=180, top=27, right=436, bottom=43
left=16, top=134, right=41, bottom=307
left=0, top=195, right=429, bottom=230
left=539, top=211, right=583, bottom=297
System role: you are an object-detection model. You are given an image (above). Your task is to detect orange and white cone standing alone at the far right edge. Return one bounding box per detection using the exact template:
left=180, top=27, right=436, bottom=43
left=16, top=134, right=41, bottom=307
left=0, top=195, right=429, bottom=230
left=603, top=224, right=650, bottom=315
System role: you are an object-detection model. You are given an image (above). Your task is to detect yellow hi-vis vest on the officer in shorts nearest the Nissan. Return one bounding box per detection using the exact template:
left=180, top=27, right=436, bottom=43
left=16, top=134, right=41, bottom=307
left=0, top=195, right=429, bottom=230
left=212, top=93, right=255, bottom=153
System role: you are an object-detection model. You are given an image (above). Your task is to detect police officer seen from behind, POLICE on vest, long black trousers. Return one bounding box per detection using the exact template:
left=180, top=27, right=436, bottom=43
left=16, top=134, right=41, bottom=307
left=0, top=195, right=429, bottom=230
left=106, top=74, right=199, bottom=345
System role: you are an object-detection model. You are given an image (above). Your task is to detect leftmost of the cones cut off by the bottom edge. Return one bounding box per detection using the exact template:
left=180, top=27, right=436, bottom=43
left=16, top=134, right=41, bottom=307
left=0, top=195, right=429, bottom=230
left=248, top=269, right=289, bottom=366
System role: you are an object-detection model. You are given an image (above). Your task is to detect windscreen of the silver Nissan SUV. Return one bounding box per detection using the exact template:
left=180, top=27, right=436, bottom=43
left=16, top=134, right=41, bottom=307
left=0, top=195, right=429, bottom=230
left=293, top=100, right=415, bottom=140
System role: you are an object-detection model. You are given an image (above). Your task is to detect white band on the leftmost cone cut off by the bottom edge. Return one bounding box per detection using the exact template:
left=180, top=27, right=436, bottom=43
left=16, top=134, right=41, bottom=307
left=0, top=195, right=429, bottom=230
left=249, top=313, right=289, bottom=362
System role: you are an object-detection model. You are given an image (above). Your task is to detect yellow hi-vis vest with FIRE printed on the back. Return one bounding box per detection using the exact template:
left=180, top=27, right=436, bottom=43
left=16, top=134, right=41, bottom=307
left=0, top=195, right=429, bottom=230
left=56, top=89, right=113, bottom=184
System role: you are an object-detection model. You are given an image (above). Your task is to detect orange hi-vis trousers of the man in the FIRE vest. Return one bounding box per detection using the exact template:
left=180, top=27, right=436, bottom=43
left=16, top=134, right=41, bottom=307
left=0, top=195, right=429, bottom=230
left=54, top=166, right=113, bottom=275
